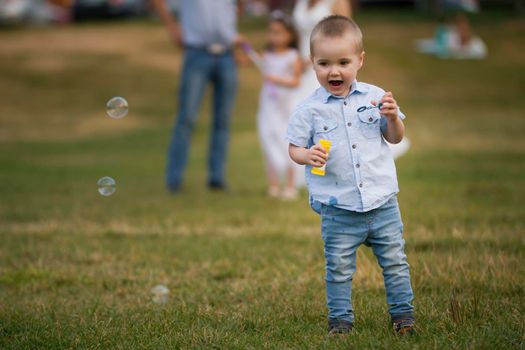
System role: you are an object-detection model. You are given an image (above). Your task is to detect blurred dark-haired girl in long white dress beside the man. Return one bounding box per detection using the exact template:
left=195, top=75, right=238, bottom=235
left=253, top=11, right=301, bottom=199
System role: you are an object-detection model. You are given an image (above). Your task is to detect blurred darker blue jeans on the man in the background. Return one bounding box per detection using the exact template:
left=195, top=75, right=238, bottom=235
left=166, top=48, right=237, bottom=190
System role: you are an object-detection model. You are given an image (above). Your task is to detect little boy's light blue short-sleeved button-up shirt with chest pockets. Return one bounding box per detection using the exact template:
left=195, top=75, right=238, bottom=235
left=286, top=81, right=405, bottom=212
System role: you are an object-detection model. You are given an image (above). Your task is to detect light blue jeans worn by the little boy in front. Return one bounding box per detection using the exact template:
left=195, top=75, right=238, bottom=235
left=321, top=196, right=414, bottom=322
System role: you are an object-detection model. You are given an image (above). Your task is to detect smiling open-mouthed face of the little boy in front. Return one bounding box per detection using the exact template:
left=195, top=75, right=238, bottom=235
left=312, top=32, right=365, bottom=96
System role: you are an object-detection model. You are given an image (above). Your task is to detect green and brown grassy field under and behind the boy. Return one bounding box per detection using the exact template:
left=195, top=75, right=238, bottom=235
left=0, top=9, right=525, bottom=349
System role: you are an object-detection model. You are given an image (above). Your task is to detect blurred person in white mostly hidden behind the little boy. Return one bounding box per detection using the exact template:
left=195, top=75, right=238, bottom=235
left=291, top=0, right=410, bottom=159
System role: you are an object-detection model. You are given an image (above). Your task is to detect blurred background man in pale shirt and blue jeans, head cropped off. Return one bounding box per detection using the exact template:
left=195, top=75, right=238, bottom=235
left=153, top=0, right=240, bottom=193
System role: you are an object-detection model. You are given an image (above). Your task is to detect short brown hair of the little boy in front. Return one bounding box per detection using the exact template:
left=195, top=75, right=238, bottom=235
left=310, top=15, right=364, bottom=56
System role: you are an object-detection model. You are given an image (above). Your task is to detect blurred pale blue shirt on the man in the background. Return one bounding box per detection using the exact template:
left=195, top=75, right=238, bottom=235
left=179, top=0, right=237, bottom=47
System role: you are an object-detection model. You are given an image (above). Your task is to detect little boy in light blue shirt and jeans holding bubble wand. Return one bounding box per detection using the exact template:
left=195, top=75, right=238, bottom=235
left=287, top=16, right=414, bottom=335
